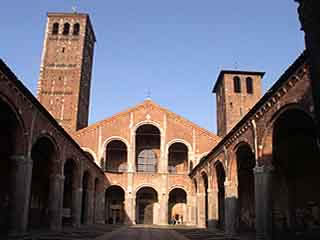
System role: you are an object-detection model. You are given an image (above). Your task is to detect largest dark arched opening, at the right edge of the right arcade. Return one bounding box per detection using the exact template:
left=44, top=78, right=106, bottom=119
left=271, top=109, right=320, bottom=239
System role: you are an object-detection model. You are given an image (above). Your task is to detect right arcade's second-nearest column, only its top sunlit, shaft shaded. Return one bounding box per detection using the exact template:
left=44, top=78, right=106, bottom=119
left=225, top=181, right=239, bottom=237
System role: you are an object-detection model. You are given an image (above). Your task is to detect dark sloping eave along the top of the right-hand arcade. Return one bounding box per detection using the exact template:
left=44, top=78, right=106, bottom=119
left=189, top=50, right=309, bottom=177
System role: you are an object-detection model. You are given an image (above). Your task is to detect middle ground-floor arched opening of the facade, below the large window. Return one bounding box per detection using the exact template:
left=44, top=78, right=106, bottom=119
left=136, top=187, right=159, bottom=224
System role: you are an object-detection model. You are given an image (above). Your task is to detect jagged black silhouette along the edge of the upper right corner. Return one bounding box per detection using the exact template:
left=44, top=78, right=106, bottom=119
left=295, top=0, right=320, bottom=123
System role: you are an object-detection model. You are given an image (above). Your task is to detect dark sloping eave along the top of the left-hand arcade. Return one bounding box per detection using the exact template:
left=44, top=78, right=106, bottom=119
left=0, top=58, right=104, bottom=175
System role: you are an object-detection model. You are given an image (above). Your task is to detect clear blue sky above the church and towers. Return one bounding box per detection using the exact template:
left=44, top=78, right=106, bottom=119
left=0, top=0, right=304, bottom=132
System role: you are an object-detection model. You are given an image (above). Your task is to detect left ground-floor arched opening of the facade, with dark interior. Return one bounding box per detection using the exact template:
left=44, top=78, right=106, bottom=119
left=105, top=186, right=126, bottom=224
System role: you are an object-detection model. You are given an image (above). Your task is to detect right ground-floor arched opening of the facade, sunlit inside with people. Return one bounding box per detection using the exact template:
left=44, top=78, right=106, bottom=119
left=168, top=188, right=187, bottom=224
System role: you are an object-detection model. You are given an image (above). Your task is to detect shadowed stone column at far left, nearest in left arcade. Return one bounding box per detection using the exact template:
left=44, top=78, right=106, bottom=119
left=10, top=155, right=33, bottom=235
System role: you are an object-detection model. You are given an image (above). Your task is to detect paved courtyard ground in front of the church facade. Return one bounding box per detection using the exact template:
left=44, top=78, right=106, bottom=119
left=5, top=224, right=254, bottom=240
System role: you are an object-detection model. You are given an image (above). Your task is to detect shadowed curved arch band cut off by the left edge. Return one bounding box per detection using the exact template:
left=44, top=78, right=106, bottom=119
left=0, top=94, right=27, bottom=155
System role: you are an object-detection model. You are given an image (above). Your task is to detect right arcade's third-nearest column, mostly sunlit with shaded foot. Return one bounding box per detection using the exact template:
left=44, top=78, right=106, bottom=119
left=208, top=189, right=219, bottom=230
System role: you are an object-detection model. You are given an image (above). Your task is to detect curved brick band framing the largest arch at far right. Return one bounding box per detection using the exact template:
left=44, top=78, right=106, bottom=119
left=258, top=103, right=315, bottom=167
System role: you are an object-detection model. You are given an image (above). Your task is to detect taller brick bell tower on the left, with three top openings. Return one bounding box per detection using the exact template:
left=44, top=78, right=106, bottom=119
left=37, top=13, right=96, bottom=133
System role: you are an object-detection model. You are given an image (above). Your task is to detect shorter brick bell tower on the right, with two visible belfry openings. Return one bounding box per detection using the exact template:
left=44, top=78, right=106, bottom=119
left=212, top=70, right=265, bottom=137
